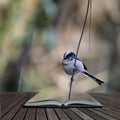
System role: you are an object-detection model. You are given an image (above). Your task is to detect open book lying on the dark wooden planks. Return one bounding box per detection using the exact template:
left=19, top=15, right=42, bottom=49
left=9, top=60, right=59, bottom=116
left=24, top=94, right=102, bottom=108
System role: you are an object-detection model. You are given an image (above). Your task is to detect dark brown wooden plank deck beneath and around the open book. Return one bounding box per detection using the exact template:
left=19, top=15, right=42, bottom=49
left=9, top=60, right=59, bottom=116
left=0, top=92, right=120, bottom=120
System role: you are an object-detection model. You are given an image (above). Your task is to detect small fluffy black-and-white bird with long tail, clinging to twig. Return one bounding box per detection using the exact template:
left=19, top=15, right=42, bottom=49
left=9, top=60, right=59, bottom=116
left=62, top=51, right=104, bottom=85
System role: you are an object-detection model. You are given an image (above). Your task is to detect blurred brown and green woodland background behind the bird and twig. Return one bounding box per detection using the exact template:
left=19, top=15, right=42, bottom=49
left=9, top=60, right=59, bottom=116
left=0, top=0, right=120, bottom=95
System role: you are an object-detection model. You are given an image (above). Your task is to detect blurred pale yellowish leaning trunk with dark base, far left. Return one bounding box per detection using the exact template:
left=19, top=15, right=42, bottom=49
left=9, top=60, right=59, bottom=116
left=0, top=0, right=38, bottom=91
